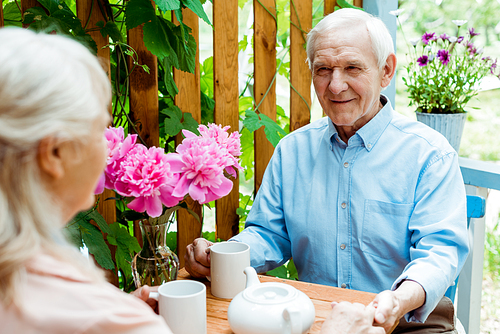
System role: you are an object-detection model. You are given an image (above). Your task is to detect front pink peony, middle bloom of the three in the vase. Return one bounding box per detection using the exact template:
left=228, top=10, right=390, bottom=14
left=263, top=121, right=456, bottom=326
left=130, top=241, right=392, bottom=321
left=115, top=144, right=184, bottom=217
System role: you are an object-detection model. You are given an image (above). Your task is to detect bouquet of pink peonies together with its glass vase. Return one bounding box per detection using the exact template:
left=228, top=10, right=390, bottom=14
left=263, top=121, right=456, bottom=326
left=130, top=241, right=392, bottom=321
left=98, top=124, right=242, bottom=287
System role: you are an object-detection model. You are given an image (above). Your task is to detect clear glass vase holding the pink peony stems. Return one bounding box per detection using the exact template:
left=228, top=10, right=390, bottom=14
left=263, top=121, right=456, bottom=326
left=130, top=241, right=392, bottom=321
left=132, top=219, right=179, bottom=288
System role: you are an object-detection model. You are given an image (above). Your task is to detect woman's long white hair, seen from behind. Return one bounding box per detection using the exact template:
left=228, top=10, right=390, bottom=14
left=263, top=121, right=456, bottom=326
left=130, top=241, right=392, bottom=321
left=0, top=28, right=111, bottom=304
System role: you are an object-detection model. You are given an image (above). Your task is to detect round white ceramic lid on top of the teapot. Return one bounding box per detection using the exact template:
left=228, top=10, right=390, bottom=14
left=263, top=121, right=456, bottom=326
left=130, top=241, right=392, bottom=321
left=243, top=283, right=298, bottom=304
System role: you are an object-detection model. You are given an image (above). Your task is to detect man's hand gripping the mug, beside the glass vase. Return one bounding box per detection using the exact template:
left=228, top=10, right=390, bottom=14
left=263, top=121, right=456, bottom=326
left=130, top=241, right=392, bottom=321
left=184, top=238, right=213, bottom=278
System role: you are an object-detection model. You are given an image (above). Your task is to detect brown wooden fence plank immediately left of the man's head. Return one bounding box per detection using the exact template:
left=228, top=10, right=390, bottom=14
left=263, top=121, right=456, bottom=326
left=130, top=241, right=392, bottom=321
left=290, top=0, right=312, bottom=131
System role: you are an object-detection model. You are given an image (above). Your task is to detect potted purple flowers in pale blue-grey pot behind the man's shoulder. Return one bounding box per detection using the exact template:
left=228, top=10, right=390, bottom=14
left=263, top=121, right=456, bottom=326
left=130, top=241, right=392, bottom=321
left=392, top=10, right=497, bottom=152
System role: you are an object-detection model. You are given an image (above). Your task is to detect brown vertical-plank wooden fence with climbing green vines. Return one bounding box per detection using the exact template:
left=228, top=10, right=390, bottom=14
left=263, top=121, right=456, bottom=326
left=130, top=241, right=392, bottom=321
left=0, top=0, right=362, bottom=276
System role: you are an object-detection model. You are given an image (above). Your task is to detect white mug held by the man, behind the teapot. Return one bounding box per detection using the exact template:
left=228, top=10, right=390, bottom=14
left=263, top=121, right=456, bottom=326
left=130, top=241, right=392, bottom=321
left=210, top=241, right=250, bottom=298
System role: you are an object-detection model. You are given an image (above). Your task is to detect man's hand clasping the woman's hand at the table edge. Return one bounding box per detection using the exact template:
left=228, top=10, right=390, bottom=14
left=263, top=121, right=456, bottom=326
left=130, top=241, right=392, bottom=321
left=370, top=280, right=425, bottom=332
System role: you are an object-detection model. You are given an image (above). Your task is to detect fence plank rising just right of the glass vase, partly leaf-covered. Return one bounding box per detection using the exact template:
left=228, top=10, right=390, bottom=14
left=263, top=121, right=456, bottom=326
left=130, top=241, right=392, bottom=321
left=172, top=9, right=203, bottom=267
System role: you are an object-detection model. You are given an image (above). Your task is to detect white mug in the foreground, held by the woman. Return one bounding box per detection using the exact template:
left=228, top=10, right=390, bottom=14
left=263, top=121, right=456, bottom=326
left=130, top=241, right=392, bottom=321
left=149, top=280, right=207, bottom=334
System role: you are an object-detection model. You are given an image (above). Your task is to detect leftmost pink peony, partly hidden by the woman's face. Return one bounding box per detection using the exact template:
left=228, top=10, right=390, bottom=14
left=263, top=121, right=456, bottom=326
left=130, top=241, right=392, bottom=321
left=104, top=126, right=137, bottom=189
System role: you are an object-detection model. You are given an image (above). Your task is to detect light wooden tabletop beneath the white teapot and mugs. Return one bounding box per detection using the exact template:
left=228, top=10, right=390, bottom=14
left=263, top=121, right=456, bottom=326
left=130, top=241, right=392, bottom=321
left=179, top=268, right=392, bottom=334
